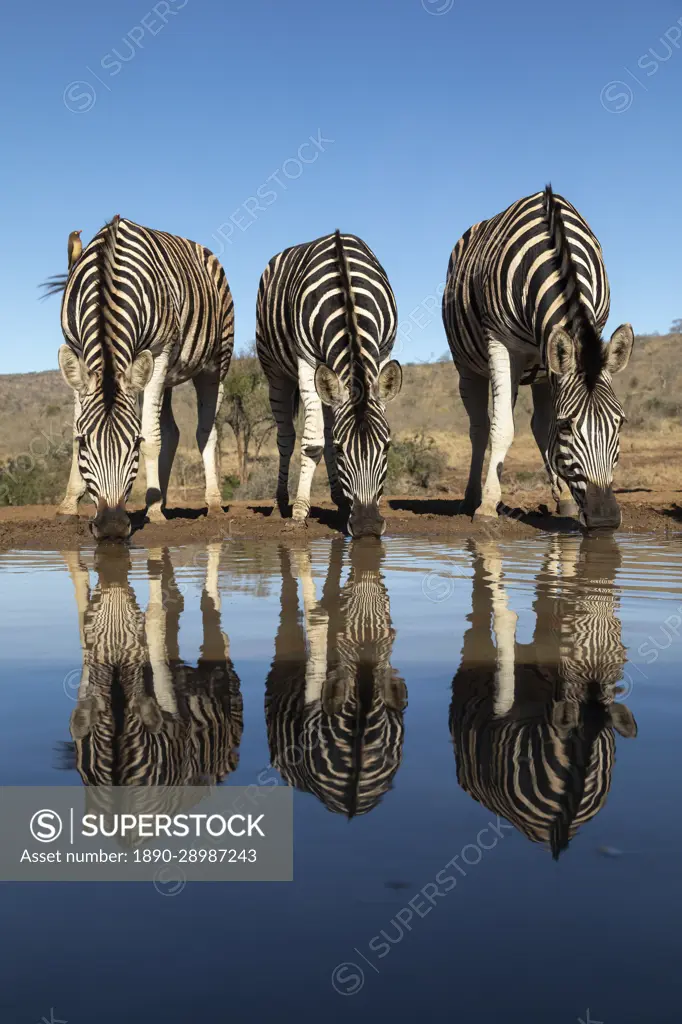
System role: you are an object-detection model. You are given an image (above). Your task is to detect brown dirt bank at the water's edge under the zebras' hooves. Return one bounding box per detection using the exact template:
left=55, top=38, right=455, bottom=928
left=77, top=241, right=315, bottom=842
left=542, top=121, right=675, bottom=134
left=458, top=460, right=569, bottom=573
left=0, top=490, right=682, bottom=550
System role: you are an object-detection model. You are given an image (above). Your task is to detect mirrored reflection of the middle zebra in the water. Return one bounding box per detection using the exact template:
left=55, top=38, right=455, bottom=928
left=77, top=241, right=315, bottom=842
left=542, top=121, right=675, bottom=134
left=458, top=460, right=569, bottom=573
left=265, top=538, right=408, bottom=818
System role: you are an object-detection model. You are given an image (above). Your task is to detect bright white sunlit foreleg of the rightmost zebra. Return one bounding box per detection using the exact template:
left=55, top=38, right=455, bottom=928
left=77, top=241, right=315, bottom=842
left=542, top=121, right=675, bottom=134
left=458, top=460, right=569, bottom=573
left=476, top=335, right=518, bottom=517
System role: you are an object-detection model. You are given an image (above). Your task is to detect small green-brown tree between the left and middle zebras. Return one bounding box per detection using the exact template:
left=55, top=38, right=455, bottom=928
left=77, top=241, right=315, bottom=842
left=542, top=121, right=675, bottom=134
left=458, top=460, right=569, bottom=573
left=222, top=342, right=275, bottom=484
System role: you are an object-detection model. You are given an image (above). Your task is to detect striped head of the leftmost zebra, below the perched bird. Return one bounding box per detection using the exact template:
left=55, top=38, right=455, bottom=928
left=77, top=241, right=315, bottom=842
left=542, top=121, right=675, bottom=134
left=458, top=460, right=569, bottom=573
left=59, top=345, right=154, bottom=541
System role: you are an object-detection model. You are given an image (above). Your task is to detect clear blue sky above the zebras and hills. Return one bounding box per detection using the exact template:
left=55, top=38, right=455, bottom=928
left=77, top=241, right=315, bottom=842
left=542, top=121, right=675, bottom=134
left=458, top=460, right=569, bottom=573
left=0, top=0, right=682, bottom=373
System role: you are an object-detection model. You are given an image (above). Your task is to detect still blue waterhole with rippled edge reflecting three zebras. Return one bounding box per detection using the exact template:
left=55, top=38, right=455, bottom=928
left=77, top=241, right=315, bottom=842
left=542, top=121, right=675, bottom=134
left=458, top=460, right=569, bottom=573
left=0, top=537, right=682, bottom=1024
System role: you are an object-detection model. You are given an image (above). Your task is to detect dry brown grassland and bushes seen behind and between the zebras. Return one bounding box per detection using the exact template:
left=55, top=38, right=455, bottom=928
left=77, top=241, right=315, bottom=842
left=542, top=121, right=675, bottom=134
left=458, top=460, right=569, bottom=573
left=0, top=334, right=682, bottom=505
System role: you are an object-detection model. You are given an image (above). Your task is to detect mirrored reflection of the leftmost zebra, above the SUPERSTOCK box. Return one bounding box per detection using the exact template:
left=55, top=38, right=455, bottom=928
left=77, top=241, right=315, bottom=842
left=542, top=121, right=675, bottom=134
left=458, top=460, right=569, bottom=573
left=62, top=542, right=244, bottom=827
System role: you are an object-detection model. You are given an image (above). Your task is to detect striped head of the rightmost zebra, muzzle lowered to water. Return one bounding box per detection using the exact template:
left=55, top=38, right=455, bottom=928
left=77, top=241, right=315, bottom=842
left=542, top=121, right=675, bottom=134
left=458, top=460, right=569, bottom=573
left=547, top=324, right=635, bottom=529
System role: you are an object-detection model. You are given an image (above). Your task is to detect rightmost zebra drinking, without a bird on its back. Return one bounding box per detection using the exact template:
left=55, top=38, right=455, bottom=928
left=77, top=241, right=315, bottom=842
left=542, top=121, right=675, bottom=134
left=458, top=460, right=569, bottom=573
left=442, top=185, right=634, bottom=528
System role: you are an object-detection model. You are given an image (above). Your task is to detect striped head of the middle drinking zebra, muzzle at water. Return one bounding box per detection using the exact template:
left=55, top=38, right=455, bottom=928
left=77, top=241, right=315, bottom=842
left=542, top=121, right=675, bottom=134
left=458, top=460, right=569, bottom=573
left=315, top=359, right=402, bottom=538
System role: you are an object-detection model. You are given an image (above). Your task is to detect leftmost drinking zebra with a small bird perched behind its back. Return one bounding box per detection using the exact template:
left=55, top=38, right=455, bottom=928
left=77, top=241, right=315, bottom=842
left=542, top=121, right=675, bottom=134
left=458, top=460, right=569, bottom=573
left=46, top=216, right=235, bottom=540
